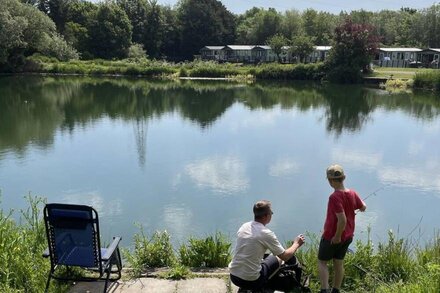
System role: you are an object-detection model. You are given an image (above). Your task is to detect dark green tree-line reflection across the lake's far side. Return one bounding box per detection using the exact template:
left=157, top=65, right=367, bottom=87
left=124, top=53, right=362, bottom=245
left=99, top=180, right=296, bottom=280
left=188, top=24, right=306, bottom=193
left=0, top=77, right=440, bottom=165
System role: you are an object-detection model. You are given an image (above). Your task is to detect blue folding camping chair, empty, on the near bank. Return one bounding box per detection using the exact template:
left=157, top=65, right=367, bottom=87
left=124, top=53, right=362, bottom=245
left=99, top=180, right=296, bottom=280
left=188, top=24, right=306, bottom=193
left=43, top=203, right=122, bottom=292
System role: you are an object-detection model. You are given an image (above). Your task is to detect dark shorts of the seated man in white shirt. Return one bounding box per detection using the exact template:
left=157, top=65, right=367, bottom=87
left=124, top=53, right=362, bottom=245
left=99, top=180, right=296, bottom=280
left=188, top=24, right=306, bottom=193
left=231, top=254, right=280, bottom=290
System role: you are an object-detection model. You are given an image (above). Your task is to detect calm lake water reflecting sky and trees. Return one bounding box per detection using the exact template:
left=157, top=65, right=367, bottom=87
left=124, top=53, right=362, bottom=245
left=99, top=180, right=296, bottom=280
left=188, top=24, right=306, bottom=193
left=0, top=76, right=440, bottom=246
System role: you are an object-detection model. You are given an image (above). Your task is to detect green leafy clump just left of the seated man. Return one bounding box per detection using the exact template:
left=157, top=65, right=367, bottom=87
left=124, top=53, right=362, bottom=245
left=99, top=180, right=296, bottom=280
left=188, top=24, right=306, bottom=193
left=179, top=232, right=231, bottom=268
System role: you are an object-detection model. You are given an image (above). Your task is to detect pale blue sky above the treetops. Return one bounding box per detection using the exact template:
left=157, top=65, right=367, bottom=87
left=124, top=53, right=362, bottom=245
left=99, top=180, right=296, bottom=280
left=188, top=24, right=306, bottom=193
left=158, top=0, right=440, bottom=13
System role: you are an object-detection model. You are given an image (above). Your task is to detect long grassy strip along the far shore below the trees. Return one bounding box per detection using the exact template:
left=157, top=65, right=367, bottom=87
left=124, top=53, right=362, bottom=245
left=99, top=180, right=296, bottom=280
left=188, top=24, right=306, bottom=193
left=24, top=56, right=324, bottom=80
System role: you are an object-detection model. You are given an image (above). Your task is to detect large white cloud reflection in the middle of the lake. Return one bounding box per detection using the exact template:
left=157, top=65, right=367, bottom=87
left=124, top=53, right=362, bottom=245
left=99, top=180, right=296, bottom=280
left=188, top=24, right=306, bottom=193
left=185, top=156, right=249, bottom=194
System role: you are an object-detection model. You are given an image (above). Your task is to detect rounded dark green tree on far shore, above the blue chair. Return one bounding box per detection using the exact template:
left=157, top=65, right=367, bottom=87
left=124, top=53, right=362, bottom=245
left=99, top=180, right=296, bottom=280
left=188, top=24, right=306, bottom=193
left=89, top=3, right=132, bottom=59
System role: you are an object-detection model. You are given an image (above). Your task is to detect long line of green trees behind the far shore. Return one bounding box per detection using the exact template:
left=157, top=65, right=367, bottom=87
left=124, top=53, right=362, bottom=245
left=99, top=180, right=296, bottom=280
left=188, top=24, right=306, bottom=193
left=0, top=0, right=440, bottom=66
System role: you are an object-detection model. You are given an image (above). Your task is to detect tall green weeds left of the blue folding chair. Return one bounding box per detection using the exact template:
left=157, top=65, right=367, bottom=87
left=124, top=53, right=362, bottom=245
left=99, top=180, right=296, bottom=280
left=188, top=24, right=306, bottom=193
left=0, top=195, right=67, bottom=293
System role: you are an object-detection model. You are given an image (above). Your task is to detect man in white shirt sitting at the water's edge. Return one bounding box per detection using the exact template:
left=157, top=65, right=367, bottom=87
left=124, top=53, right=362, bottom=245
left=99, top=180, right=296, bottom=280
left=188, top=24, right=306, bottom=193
left=229, top=200, right=305, bottom=290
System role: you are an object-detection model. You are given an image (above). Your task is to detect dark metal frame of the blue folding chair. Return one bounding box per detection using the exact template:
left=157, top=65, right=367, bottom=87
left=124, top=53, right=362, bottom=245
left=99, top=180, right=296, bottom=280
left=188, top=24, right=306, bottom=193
left=43, top=203, right=122, bottom=293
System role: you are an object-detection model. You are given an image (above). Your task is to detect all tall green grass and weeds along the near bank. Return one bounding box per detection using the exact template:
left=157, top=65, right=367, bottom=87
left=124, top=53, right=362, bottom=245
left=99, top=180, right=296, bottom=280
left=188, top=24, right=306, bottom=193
left=0, top=196, right=440, bottom=293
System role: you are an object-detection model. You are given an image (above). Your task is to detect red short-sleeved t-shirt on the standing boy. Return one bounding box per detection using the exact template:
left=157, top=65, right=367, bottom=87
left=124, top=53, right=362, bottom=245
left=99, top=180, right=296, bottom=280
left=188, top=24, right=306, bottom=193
left=322, top=189, right=363, bottom=241
